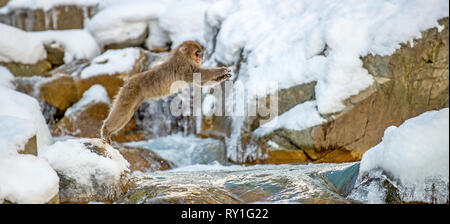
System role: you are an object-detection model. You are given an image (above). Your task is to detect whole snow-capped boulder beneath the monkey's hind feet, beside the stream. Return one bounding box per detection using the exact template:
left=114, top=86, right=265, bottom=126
left=40, top=139, right=132, bottom=203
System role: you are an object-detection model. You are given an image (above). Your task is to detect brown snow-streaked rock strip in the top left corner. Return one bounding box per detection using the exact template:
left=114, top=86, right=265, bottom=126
left=0, top=5, right=98, bottom=31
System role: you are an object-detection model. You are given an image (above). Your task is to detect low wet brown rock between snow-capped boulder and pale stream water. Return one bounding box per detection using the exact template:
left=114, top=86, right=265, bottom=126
left=119, top=146, right=175, bottom=172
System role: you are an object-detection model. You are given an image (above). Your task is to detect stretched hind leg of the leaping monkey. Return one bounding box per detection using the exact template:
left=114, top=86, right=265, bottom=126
left=100, top=88, right=143, bottom=144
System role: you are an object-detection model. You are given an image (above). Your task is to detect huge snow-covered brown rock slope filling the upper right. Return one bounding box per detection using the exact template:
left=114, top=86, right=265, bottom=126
left=204, top=0, right=449, bottom=162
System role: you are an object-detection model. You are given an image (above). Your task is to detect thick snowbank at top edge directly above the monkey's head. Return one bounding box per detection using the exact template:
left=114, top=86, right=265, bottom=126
left=87, top=0, right=214, bottom=49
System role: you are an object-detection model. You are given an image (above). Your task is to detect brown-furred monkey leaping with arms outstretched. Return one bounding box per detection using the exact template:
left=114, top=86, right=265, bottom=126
left=101, top=41, right=231, bottom=143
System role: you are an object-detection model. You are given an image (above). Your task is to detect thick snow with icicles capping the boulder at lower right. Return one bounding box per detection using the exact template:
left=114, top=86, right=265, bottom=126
left=359, top=108, right=449, bottom=202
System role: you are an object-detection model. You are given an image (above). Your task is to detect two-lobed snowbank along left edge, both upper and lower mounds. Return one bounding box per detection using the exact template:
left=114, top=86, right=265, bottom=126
left=0, top=86, right=59, bottom=203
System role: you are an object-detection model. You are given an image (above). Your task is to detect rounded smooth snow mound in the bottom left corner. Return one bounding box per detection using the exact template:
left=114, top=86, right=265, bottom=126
left=0, top=153, right=59, bottom=204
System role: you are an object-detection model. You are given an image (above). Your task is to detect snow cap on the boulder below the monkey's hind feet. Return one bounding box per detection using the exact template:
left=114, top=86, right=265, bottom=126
left=40, top=139, right=129, bottom=187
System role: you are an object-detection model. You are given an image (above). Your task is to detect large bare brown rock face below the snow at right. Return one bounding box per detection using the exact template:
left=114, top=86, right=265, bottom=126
left=252, top=18, right=449, bottom=162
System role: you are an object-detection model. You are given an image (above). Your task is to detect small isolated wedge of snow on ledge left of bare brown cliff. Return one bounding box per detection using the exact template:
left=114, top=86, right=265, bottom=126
left=253, top=101, right=326, bottom=136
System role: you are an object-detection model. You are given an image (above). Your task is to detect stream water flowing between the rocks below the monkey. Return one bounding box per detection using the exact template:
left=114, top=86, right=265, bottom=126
left=119, top=135, right=353, bottom=203
